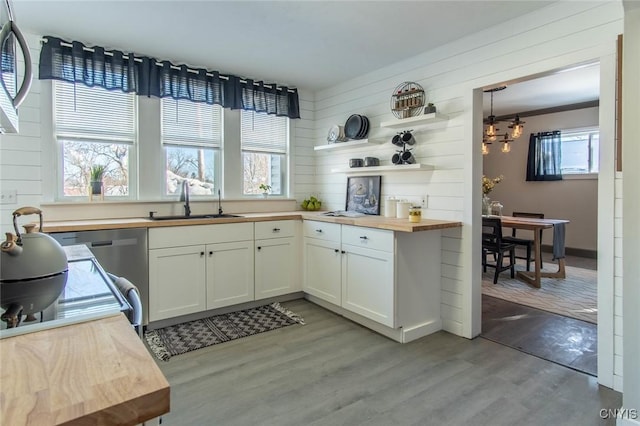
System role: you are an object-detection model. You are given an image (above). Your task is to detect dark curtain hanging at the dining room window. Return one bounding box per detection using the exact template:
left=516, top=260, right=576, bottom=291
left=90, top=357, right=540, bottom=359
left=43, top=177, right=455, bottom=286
left=527, top=130, right=562, bottom=181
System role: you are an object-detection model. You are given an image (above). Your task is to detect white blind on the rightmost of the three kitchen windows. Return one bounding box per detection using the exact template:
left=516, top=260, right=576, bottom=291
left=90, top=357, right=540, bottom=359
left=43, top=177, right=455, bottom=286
left=240, top=110, right=288, bottom=154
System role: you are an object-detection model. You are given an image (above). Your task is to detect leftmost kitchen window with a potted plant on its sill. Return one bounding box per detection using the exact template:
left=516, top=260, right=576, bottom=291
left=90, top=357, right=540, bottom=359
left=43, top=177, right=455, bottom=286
left=53, top=81, right=137, bottom=197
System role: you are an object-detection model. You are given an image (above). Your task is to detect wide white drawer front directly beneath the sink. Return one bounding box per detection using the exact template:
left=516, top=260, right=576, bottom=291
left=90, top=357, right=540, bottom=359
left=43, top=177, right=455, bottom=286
left=149, top=223, right=253, bottom=249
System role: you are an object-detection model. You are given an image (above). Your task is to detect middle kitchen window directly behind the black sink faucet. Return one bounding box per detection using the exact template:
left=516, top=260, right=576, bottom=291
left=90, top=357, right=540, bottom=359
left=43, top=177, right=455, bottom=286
left=162, top=98, right=222, bottom=196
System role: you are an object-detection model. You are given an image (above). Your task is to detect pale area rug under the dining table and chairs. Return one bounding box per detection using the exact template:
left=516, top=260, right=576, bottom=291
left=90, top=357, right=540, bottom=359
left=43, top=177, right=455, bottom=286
left=482, top=262, right=598, bottom=324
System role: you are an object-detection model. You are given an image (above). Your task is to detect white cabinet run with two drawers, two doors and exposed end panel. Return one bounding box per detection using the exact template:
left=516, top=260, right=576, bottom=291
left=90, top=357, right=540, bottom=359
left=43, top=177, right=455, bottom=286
left=303, top=221, right=442, bottom=342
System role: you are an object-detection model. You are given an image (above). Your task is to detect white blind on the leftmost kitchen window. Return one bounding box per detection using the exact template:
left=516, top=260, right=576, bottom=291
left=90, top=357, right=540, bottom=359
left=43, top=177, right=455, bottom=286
left=54, top=81, right=136, bottom=144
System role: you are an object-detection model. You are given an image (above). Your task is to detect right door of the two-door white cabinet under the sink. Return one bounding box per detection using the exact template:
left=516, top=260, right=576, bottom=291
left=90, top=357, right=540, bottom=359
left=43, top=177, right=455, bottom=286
left=206, top=241, right=254, bottom=309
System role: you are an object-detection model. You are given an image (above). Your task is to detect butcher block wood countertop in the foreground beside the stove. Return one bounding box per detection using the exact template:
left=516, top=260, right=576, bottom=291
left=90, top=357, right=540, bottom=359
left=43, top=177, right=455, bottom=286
left=0, top=314, right=170, bottom=426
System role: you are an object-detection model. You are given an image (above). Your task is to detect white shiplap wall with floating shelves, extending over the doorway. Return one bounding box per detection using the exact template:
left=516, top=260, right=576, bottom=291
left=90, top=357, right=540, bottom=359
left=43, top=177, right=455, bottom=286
left=315, top=2, right=622, bottom=356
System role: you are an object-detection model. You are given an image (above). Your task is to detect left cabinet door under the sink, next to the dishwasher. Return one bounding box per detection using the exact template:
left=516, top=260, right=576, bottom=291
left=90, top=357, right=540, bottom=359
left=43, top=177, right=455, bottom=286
left=149, top=246, right=206, bottom=321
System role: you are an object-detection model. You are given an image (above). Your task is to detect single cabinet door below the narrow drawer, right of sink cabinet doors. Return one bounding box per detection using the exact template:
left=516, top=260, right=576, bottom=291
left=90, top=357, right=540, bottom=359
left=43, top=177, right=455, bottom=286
left=255, top=237, right=301, bottom=300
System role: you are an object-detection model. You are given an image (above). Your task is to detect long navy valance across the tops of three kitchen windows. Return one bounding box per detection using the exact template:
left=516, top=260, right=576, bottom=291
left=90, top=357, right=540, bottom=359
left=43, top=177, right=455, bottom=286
left=39, top=36, right=300, bottom=118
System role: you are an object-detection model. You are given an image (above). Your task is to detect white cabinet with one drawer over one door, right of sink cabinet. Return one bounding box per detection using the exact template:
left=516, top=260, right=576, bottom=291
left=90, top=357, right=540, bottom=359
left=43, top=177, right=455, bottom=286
left=255, top=220, right=302, bottom=300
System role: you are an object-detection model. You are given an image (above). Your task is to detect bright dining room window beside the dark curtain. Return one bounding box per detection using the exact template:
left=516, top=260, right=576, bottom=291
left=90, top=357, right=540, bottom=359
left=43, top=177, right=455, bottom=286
left=560, top=129, right=600, bottom=175
